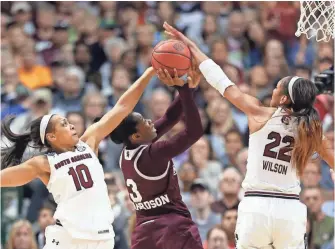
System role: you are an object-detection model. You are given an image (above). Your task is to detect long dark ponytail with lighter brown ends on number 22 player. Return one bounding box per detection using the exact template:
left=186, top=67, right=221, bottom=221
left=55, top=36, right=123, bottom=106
left=283, top=77, right=322, bottom=176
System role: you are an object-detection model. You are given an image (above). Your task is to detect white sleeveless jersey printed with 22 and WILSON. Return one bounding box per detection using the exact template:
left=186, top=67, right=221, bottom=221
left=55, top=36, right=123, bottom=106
left=242, top=108, right=301, bottom=194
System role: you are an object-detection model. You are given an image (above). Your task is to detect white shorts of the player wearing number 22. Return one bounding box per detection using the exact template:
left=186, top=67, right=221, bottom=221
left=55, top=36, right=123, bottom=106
left=235, top=196, right=307, bottom=249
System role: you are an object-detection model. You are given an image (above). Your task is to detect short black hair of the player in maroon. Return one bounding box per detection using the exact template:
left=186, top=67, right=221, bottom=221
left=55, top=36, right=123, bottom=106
left=94, top=113, right=138, bottom=145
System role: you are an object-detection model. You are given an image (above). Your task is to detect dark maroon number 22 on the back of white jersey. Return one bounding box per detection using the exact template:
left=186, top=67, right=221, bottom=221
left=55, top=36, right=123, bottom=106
left=263, top=131, right=294, bottom=162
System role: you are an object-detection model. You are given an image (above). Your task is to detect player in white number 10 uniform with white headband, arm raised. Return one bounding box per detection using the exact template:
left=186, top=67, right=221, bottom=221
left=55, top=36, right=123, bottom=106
left=0, top=68, right=177, bottom=249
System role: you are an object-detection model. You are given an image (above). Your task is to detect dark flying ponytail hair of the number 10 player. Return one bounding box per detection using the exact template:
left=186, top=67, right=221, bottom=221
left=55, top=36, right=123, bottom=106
left=1, top=116, right=52, bottom=168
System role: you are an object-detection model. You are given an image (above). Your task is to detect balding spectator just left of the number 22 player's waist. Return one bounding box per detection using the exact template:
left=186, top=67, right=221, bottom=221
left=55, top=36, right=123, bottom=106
left=211, top=168, right=242, bottom=214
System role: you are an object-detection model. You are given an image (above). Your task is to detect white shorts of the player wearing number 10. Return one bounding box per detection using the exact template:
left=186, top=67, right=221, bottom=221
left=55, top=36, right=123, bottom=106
left=43, top=225, right=114, bottom=249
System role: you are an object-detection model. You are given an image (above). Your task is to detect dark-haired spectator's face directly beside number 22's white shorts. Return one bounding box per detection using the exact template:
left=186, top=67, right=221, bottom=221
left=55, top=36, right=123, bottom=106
left=221, top=208, right=237, bottom=249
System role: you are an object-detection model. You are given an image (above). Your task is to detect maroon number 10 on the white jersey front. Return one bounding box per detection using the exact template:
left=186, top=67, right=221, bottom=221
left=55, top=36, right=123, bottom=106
left=68, top=164, right=93, bottom=191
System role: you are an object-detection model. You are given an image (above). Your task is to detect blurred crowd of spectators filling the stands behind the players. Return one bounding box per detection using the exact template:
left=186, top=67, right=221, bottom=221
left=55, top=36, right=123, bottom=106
left=1, top=1, right=334, bottom=249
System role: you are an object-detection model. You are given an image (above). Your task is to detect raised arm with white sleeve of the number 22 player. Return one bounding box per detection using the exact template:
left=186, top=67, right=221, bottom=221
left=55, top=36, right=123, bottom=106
left=164, top=22, right=263, bottom=115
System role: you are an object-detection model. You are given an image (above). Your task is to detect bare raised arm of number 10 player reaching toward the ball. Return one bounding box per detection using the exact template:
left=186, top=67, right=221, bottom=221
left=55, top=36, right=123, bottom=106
left=80, top=67, right=155, bottom=153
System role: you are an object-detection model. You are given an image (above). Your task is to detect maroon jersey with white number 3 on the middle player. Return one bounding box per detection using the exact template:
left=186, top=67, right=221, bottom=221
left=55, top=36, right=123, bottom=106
left=120, top=144, right=191, bottom=223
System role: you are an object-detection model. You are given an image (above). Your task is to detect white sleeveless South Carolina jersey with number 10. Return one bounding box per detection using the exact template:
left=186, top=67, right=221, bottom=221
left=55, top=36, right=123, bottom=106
left=47, top=141, right=114, bottom=240
